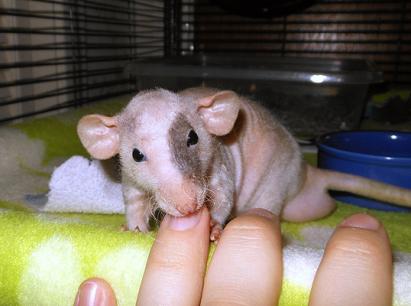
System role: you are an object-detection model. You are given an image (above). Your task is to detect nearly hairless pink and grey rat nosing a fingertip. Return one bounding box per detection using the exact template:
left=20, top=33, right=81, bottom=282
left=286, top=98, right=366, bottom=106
left=77, top=87, right=411, bottom=240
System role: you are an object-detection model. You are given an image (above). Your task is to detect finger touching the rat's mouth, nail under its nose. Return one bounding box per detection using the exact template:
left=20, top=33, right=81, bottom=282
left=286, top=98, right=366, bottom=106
left=137, top=208, right=210, bottom=306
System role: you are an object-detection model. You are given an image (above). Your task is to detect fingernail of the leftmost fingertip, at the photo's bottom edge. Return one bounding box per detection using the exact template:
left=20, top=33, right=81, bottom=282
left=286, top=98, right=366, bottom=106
left=74, top=281, right=110, bottom=306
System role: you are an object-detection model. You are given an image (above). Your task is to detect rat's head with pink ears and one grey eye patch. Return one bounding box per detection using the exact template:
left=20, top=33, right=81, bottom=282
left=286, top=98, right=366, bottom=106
left=78, top=89, right=239, bottom=216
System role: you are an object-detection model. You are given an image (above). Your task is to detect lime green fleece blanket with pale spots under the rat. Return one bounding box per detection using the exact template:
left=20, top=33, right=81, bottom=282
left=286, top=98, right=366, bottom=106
left=0, top=97, right=411, bottom=306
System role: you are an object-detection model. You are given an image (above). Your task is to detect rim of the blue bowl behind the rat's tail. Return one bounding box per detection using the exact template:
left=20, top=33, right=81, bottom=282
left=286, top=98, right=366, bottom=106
left=315, top=130, right=411, bottom=167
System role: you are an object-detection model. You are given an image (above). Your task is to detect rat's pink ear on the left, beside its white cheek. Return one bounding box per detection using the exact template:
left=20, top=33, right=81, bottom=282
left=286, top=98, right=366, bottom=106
left=77, top=115, right=120, bottom=159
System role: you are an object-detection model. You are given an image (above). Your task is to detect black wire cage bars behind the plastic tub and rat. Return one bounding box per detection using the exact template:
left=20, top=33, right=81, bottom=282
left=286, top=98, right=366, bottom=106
left=0, top=0, right=411, bottom=122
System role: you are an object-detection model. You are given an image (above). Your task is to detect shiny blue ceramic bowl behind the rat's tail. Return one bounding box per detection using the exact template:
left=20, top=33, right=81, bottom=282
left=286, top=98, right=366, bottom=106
left=317, top=131, right=411, bottom=211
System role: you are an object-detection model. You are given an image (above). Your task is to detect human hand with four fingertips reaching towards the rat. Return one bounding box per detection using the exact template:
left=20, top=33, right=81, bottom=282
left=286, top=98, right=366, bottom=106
left=76, top=209, right=392, bottom=306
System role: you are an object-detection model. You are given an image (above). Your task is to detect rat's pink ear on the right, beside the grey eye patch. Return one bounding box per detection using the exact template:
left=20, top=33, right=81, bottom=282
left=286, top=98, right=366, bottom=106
left=198, top=90, right=240, bottom=136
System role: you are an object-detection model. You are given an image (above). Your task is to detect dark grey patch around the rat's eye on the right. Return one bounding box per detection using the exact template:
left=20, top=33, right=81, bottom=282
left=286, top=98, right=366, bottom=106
left=169, top=114, right=201, bottom=178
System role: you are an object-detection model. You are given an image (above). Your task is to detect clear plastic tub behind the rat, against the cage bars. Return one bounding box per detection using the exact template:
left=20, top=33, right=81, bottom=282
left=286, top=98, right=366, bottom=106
left=126, top=55, right=383, bottom=136
